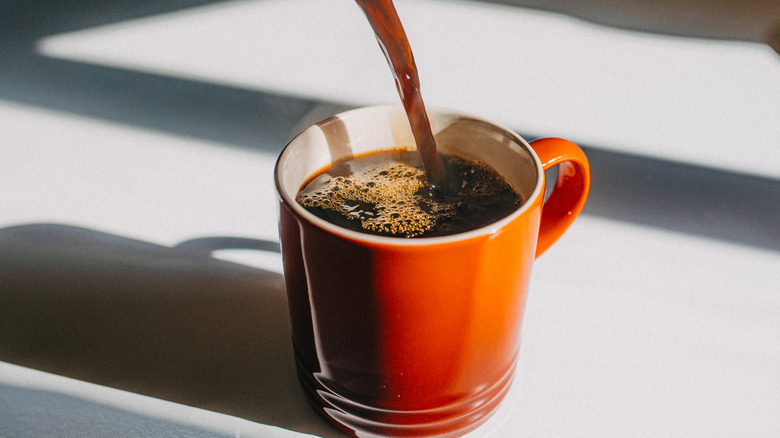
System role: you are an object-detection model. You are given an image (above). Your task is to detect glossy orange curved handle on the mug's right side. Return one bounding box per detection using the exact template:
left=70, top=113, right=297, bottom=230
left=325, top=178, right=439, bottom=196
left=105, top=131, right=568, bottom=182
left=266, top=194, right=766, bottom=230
left=530, top=137, right=590, bottom=257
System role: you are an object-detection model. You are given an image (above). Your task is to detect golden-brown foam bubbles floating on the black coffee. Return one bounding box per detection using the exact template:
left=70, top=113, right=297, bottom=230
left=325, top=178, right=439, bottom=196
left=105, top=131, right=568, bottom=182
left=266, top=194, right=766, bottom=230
left=298, top=162, right=454, bottom=237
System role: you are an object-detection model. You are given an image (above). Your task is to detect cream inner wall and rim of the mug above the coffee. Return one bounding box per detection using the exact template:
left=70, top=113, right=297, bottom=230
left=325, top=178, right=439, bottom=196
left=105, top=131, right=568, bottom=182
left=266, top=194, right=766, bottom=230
left=275, top=105, right=544, bottom=245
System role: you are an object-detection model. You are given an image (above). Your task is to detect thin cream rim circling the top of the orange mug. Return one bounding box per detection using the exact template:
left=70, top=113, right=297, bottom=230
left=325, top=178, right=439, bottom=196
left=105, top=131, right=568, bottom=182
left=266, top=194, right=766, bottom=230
left=274, top=105, right=544, bottom=247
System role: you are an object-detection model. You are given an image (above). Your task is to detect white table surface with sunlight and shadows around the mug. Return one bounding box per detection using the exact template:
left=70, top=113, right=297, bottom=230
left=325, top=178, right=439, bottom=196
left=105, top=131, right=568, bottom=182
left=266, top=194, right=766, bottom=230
left=0, top=0, right=780, bottom=437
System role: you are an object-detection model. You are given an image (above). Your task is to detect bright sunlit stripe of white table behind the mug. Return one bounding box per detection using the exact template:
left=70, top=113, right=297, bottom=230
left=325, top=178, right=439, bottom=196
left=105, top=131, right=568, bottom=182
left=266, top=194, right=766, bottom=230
left=39, top=0, right=780, bottom=178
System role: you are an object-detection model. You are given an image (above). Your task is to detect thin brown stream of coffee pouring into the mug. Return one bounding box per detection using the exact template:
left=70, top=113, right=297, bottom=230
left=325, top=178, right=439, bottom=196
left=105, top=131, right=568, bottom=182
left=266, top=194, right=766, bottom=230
left=356, top=0, right=448, bottom=192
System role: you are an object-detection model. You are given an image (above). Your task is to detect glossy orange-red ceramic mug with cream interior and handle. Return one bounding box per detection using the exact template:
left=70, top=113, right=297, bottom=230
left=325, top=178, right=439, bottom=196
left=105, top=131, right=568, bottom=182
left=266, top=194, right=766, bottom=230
left=275, top=106, right=590, bottom=437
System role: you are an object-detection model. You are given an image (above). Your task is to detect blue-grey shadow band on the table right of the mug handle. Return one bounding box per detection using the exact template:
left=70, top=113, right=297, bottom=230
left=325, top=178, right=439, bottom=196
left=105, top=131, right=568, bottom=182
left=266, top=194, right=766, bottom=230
left=583, top=147, right=780, bottom=251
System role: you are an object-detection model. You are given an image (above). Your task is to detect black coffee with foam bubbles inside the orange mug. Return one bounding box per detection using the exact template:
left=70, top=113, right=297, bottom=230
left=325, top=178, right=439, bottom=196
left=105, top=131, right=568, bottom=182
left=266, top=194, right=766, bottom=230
left=297, top=149, right=523, bottom=237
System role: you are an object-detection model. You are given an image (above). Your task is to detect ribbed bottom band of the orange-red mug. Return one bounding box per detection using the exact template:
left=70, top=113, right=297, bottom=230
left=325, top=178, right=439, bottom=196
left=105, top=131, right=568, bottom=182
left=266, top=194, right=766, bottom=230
left=298, top=358, right=514, bottom=438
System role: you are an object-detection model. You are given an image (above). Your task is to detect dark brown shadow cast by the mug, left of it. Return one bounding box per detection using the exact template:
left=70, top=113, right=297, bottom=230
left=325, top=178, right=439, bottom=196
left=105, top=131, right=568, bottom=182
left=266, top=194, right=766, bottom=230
left=0, top=224, right=341, bottom=436
